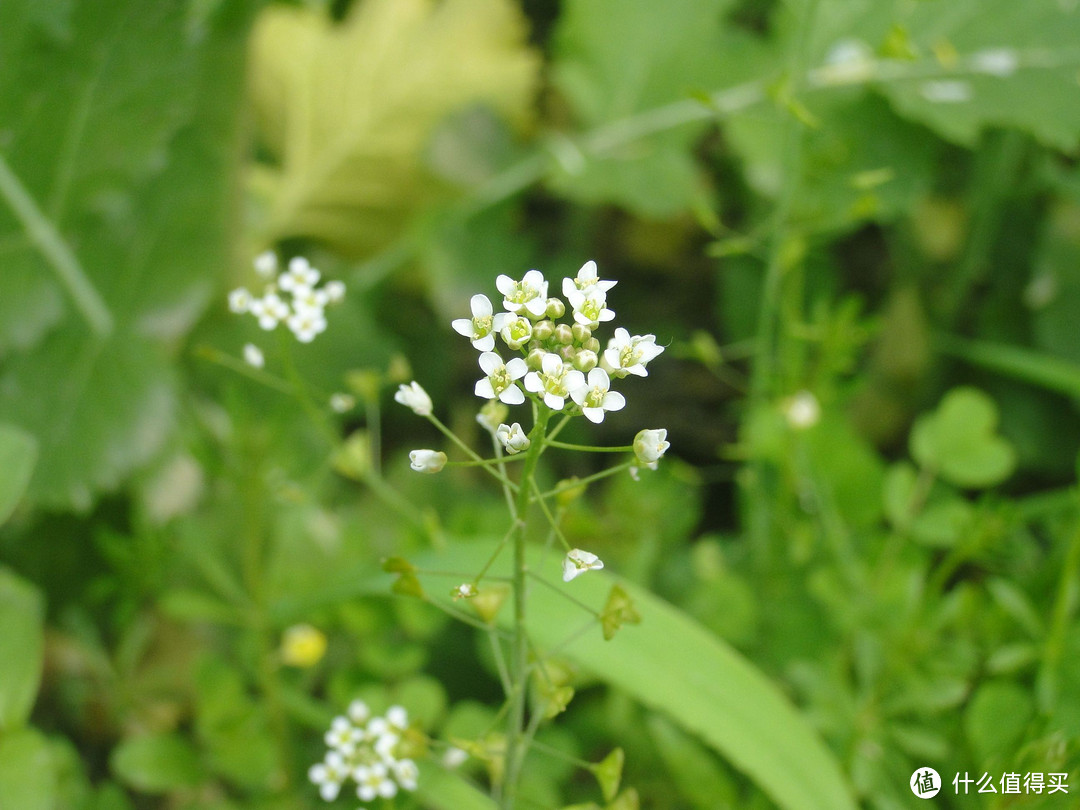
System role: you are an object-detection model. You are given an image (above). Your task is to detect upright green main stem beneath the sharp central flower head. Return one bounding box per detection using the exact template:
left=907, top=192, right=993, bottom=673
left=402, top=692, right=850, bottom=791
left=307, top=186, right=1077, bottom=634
left=501, top=403, right=552, bottom=810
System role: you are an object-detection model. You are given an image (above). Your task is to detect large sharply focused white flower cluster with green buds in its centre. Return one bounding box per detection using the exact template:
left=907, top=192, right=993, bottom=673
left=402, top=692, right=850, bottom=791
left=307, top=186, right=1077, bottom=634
left=451, top=261, right=663, bottom=427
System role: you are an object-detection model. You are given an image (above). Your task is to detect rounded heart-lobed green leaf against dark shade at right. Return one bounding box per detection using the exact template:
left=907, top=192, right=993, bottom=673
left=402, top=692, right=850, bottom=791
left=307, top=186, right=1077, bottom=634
left=910, top=388, right=1016, bottom=488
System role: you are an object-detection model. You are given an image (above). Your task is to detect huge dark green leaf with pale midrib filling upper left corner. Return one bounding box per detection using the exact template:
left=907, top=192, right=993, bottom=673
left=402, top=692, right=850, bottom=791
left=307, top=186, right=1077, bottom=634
left=0, top=0, right=257, bottom=510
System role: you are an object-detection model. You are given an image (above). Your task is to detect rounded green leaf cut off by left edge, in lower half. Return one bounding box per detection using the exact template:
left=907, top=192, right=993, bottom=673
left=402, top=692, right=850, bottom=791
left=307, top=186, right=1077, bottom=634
left=0, top=568, right=45, bottom=734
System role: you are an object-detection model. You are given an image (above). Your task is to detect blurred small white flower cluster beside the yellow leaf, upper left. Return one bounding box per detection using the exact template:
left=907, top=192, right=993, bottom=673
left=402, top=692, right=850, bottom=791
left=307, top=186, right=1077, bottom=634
left=229, top=251, right=345, bottom=343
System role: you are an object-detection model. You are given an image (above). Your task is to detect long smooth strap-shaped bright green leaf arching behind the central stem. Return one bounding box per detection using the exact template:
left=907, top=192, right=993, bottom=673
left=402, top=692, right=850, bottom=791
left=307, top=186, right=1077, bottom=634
left=417, top=543, right=855, bottom=810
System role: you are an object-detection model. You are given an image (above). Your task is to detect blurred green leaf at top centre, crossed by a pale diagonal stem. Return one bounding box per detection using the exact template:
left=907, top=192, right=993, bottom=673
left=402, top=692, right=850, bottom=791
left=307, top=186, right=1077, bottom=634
left=552, top=0, right=731, bottom=217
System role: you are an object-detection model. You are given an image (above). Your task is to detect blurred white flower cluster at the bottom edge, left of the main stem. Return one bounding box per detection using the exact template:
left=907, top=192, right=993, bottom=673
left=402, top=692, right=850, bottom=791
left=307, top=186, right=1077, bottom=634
left=308, top=700, right=420, bottom=801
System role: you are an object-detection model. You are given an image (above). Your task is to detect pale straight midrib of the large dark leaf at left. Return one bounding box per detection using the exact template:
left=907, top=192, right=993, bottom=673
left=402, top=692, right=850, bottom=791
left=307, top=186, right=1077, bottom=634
left=0, top=156, right=113, bottom=337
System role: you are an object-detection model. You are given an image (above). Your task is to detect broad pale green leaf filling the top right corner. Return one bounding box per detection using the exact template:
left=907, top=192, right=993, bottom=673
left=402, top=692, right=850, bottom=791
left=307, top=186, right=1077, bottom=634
left=813, top=0, right=1080, bottom=150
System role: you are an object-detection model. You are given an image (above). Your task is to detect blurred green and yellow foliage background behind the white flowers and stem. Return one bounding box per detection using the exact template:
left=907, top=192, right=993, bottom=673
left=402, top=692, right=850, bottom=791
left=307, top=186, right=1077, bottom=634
left=0, top=0, right=1080, bottom=810
